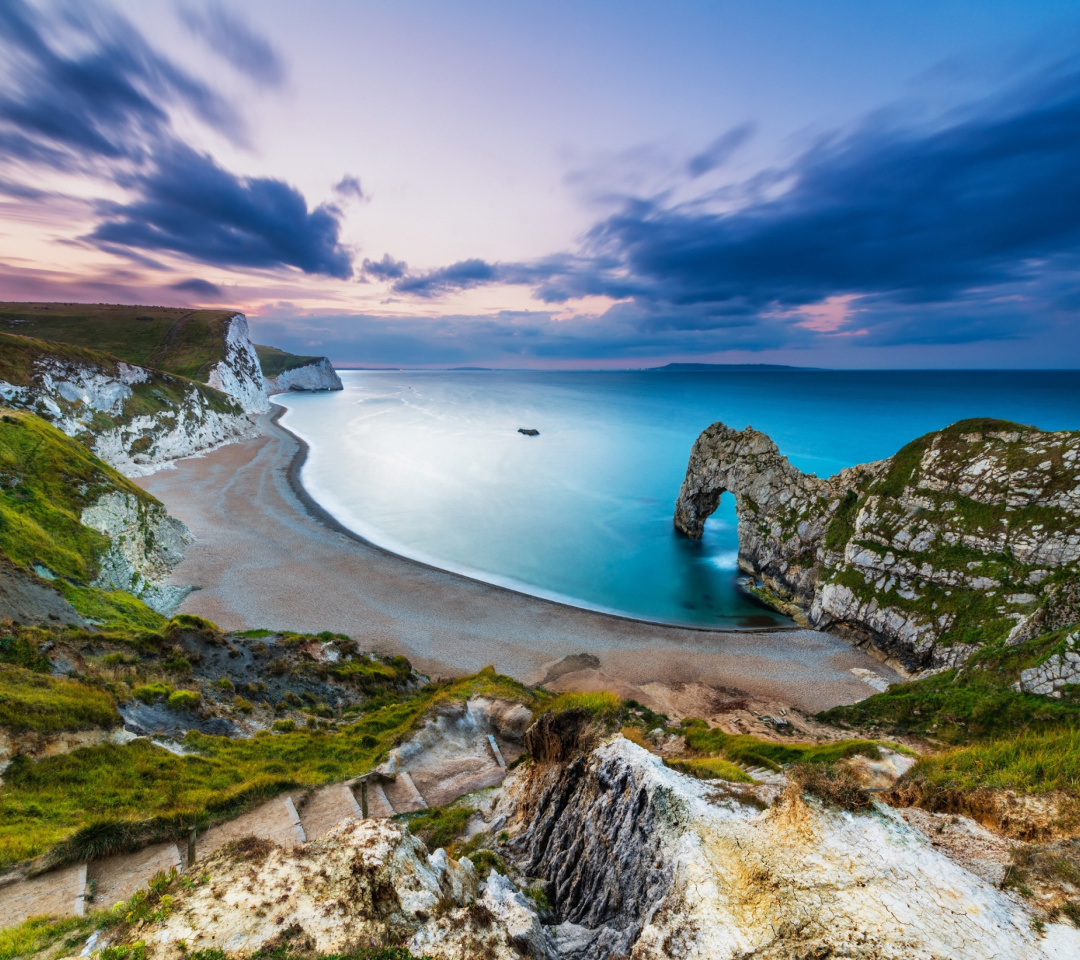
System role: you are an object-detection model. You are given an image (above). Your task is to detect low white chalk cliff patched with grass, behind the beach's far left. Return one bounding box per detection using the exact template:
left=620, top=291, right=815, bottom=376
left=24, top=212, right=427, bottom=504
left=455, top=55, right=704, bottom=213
left=0, top=325, right=259, bottom=476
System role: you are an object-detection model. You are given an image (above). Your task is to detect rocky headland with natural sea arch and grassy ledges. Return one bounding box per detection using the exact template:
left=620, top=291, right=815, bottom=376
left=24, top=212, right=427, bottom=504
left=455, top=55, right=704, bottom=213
left=675, top=420, right=1080, bottom=672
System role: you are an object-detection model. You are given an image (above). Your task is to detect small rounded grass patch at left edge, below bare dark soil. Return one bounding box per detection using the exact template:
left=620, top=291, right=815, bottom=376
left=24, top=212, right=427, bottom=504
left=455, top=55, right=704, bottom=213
left=0, top=664, right=120, bottom=734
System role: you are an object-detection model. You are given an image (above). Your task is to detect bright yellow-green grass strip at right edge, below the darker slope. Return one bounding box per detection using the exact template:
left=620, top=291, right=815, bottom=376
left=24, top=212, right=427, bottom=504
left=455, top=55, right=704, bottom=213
left=906, top=727, right=1080, bottom=795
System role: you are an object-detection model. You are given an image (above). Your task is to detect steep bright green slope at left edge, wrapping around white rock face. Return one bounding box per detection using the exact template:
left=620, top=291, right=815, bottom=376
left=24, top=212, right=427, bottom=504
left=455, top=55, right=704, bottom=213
left=0, top=410, right=164, bottom=628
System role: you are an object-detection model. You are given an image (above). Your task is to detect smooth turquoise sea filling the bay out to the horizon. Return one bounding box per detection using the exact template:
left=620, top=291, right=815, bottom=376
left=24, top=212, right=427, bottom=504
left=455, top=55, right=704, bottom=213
left=275, top=370, right=1080, bottom=626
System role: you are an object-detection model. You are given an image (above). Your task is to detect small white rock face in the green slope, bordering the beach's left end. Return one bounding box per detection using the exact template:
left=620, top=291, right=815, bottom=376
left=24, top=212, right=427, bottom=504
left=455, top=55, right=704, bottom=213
left=79, top=490, right=194, bottom=617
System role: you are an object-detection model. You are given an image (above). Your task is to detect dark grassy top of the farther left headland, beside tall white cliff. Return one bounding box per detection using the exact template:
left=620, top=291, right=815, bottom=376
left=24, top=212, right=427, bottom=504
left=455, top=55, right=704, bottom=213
left=0, top=302, right=235, bottom=383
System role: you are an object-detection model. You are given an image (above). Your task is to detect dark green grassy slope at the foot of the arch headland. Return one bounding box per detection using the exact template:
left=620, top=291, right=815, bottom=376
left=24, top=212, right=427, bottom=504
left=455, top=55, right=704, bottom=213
left=819, top=627, right=1080, bottom=745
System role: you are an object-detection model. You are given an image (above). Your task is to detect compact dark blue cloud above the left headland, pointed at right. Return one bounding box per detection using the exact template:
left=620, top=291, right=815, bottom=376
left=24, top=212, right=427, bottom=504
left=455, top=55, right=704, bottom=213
left=87, top=146, right=352, bottom=278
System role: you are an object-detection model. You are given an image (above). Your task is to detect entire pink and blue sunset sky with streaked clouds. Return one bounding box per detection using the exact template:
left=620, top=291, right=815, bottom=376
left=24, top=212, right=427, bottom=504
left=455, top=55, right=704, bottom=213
left=0, top=0, right=1080, bottom=368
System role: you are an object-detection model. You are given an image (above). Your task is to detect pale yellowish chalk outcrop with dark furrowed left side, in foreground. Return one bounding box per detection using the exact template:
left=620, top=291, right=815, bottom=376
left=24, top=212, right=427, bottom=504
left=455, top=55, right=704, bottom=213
left=499, top=736, right=1080, bottom=960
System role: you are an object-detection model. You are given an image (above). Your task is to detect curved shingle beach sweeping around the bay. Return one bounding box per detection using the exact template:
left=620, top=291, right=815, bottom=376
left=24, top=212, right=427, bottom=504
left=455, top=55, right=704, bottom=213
left=136, top=408, right=897, bottom=711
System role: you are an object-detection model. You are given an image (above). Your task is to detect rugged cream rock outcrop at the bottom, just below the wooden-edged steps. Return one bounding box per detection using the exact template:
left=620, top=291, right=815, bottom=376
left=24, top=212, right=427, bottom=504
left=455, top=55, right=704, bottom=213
left=113, top=820, right=556, bottom=960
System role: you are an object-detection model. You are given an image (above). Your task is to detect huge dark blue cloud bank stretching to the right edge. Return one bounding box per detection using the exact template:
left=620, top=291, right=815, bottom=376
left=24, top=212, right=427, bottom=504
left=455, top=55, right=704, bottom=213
left=382, top=59, right=1080, bottom=342
